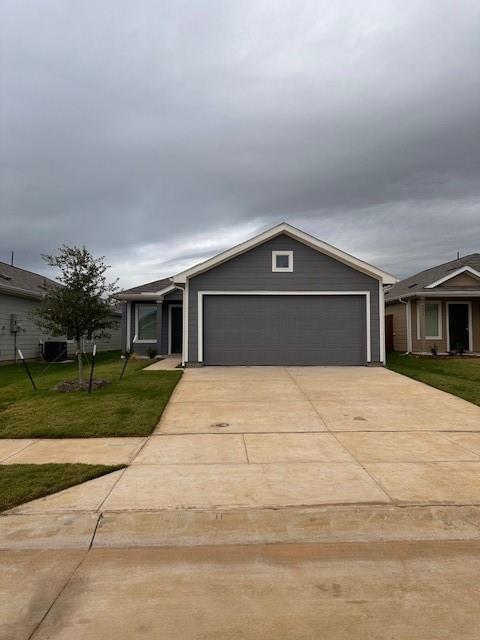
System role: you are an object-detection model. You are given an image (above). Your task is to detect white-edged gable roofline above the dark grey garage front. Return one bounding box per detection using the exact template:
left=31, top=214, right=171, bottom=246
left=173, top=222, right=397, bottom=284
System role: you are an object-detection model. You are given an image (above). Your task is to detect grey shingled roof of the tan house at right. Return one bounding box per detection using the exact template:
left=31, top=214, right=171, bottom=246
left=385, top=253, right=480, bottom=302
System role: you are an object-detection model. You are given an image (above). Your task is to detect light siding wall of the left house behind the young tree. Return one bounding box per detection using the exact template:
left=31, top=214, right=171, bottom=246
left=0, top=294, right=121, bottom=362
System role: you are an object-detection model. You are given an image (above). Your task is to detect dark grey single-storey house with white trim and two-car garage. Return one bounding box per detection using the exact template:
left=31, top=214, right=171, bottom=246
left=117, top=223, right=397, bottom=366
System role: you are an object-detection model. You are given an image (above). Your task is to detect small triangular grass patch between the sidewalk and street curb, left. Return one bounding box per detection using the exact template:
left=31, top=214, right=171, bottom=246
left=0, top=464, right=123, bottom=511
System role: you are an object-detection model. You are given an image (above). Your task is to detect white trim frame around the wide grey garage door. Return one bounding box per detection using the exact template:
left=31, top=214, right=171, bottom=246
left=197, top=291, right=372, bottom=362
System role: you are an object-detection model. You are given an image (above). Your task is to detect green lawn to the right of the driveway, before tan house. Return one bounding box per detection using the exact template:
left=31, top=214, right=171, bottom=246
left=387, top=353, right=480, bottom=406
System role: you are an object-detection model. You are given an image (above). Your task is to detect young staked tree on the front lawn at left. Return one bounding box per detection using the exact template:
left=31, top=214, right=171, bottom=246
left=35, top=245, right=118, bottom=383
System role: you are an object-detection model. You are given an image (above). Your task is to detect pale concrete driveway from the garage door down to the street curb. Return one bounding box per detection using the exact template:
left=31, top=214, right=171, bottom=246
left=9, top=367, right=480, bottom=513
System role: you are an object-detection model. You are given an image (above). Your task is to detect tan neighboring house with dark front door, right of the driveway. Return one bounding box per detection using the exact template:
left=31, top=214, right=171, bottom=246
left=385, top=253, right=480, bottom=353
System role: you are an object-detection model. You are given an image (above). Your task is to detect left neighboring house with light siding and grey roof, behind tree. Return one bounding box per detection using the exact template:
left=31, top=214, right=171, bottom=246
left=0, top=262, right=121, bottom=362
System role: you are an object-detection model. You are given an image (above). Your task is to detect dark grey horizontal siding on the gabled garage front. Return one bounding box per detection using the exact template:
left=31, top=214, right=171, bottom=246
left=188, top=234, right=380, bottom=363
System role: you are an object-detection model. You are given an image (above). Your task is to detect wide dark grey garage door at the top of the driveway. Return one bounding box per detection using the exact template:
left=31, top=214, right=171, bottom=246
left=203, top=295, right=366, bottom=365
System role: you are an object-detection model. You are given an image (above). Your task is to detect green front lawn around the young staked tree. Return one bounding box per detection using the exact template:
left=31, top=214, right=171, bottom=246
left=0, top=352, right=182, bottom=438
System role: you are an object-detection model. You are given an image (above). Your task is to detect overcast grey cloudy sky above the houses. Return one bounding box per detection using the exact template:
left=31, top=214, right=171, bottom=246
left=0, top=0, right=480, bottom=286
